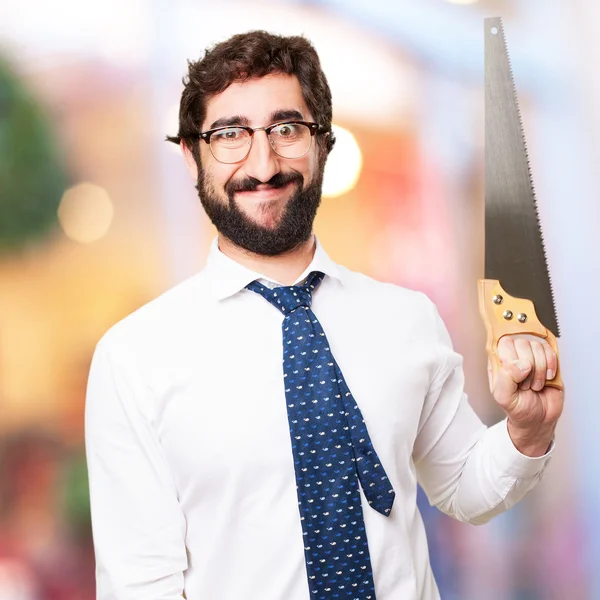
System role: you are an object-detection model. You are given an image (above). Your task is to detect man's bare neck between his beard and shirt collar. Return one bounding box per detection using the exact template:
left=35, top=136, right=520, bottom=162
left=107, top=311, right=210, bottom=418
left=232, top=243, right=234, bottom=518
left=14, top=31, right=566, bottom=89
left=218, top=234, right=316, bottom=285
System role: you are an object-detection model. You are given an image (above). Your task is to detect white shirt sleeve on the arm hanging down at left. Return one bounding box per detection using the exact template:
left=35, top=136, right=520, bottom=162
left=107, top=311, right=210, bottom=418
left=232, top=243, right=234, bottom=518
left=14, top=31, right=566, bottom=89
left=85, top=341, right=187, bottom=600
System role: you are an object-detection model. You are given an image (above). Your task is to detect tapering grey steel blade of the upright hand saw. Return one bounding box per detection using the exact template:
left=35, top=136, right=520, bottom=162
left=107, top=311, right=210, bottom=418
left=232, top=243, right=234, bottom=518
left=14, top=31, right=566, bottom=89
left=484, top=17, right=559, bottom=336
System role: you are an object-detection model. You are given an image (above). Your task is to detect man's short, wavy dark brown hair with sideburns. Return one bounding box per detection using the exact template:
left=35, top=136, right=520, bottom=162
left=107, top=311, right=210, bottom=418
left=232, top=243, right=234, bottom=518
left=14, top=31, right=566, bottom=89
left=166, top=31, right=335, bottom=164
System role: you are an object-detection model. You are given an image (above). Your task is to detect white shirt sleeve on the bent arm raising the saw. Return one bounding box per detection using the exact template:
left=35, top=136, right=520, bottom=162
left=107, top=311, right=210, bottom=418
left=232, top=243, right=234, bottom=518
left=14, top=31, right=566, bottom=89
left=413, top=305, right=554, bottom=525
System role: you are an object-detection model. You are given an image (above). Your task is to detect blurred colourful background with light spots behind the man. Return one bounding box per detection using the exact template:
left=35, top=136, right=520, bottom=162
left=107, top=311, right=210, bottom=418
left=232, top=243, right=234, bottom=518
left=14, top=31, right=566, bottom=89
left=0, top=0, right=600, bottom=600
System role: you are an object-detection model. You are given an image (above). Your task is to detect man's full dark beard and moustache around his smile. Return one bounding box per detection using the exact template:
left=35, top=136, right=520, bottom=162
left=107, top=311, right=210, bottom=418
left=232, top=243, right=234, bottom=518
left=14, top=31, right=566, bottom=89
left=196, top=165, right=324, bottom=256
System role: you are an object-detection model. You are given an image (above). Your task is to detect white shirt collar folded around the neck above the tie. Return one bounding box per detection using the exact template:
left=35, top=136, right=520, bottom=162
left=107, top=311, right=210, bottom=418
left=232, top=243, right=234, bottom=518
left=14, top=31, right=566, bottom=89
left=204, top=236, right=343, bottom=300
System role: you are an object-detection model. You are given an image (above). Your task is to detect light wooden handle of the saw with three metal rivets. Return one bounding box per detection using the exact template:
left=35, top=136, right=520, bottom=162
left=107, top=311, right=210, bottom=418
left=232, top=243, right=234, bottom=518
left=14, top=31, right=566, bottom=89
left=478, top=279, right=564, bottom=390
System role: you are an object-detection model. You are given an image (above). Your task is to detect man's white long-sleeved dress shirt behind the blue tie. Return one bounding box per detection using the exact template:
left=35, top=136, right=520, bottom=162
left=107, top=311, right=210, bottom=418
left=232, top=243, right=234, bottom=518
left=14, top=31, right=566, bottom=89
left=86, top=240, right=550, bottom=600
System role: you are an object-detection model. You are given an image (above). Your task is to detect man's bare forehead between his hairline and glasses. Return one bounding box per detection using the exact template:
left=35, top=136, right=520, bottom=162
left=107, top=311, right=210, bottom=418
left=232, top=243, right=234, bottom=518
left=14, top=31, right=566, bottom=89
left=202, top=73, right=312, bottom=129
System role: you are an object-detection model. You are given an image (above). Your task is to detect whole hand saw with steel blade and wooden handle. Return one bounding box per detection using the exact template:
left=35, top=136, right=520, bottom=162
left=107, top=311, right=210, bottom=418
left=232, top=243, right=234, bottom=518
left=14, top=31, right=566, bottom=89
left=479, top=18, right=563, bottom=389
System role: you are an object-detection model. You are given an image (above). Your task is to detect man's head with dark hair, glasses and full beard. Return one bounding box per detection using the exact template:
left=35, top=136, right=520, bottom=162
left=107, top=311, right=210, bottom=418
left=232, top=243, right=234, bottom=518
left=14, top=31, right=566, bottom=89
left=167, top=31, right=335, bottom=255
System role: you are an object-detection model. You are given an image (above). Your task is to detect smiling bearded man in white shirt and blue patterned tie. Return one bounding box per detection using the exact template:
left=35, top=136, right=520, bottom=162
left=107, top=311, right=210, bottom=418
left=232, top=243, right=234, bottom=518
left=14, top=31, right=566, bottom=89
left=86, top=31, right=563, bottom=600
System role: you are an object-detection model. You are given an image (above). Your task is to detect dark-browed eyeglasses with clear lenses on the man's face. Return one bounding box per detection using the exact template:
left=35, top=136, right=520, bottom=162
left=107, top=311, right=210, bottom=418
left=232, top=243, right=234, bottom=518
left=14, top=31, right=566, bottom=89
left=199, top=121, right=328, bottom=164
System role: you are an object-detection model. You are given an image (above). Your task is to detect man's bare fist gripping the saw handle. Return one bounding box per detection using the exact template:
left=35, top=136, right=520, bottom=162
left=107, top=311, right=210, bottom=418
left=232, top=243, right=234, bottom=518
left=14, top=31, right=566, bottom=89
left=488, top=334, right=564, bottom=456
